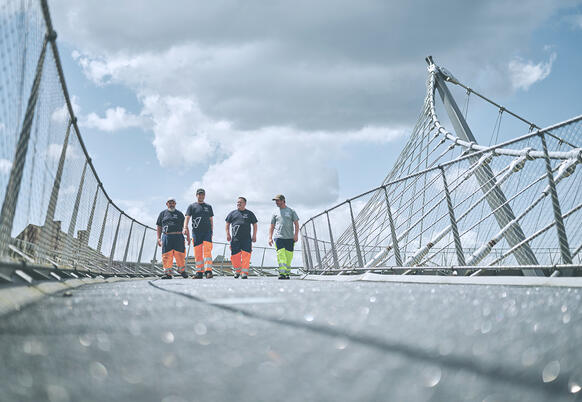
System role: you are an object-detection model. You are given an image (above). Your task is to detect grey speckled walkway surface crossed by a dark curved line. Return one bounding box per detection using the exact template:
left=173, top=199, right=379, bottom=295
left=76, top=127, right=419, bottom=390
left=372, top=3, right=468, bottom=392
left=0, top=277, right=582, bottom=402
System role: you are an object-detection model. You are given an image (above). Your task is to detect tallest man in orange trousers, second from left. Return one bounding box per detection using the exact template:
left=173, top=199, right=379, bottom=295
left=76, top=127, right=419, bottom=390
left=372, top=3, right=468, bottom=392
left=182, top=188, right=214, bottom=279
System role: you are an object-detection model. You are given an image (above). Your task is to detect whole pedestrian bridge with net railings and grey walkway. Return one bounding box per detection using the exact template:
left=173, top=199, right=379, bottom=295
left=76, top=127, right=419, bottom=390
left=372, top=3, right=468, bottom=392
left=0, top=0, right=582, bottom=402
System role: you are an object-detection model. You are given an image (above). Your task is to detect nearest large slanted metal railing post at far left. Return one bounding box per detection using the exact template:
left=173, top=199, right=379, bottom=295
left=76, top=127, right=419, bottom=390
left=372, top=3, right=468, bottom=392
left=0, top=31, right=57, bottom=256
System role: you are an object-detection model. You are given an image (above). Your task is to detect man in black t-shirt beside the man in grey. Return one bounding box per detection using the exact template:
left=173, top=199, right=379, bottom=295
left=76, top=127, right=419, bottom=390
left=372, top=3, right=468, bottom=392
left=225, top=197, right=257, bottom=279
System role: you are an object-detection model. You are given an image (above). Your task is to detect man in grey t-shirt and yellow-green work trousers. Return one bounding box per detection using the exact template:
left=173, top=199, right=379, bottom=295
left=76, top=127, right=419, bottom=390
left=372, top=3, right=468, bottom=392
left=269, top=194, right=299, bottom=279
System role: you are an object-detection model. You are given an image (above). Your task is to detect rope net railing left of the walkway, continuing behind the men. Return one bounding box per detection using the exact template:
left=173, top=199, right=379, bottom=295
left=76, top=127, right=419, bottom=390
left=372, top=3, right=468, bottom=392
left=0, top=0, right=297, bottom=279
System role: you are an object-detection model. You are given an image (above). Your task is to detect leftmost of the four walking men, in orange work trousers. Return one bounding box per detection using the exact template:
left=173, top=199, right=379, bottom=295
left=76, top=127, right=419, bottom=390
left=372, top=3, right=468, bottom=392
left=156, top=197, right=190, bottom=279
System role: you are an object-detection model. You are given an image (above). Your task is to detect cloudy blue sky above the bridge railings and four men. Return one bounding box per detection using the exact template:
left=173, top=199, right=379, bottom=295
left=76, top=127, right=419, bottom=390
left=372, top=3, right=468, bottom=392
left=49, top=0, right=582, bottom=245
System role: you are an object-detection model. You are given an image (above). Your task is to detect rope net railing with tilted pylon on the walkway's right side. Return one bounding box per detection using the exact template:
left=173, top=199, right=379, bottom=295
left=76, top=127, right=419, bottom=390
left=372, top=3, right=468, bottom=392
left=301, top=58, right=582, bottom=276
